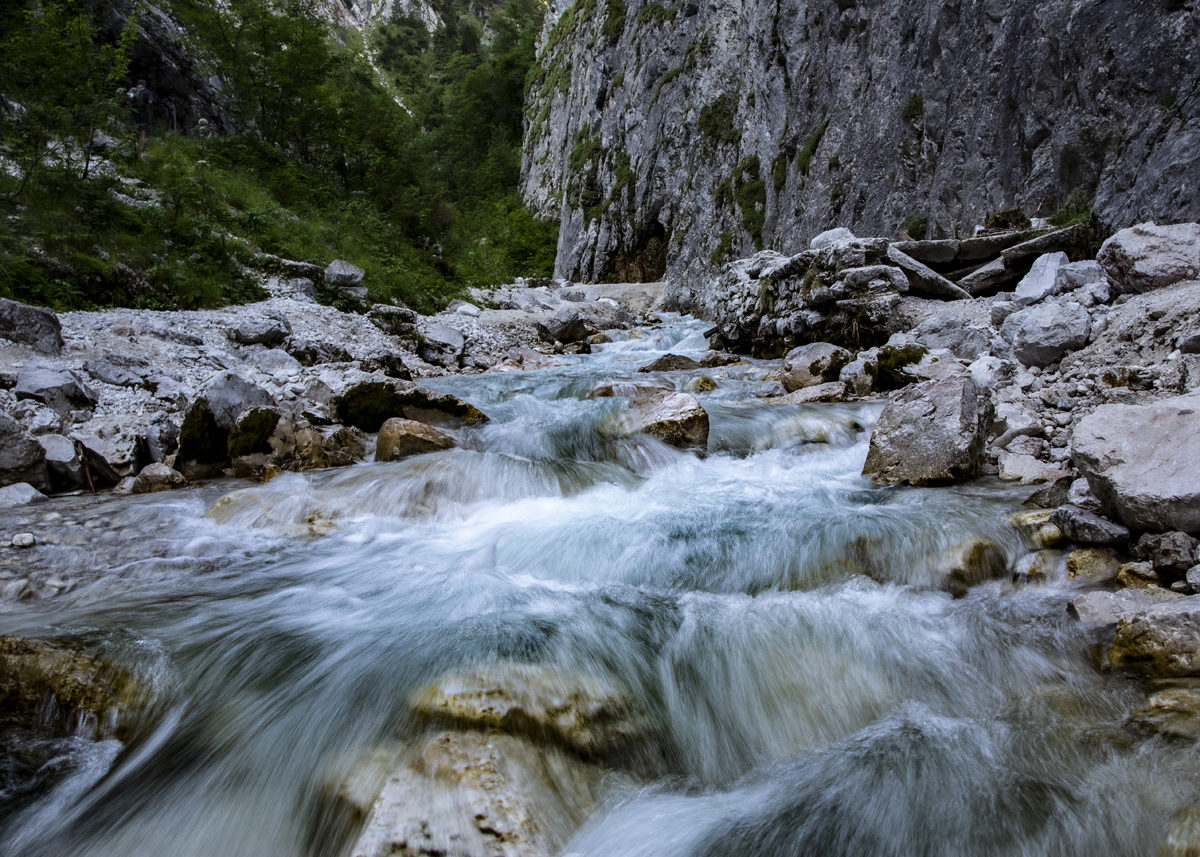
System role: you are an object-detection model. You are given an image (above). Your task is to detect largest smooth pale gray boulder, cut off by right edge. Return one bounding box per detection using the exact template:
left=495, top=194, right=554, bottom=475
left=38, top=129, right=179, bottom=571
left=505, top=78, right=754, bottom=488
left=1070, top=395, right=1200, bottom=533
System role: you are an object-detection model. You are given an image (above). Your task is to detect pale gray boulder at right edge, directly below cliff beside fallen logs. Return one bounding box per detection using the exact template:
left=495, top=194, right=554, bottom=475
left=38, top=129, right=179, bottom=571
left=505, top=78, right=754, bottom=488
left=1096, top=222, right=1200, bottom=293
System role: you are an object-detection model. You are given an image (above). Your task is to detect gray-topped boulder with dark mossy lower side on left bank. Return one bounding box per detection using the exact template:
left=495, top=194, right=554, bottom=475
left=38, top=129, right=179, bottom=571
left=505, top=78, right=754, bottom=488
left=178, top=371, right=272, bottom=478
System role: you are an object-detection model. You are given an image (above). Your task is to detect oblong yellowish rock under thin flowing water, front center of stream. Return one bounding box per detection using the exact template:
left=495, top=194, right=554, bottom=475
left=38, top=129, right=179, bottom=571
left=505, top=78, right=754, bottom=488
left=409, top=663, right=653, bottom=759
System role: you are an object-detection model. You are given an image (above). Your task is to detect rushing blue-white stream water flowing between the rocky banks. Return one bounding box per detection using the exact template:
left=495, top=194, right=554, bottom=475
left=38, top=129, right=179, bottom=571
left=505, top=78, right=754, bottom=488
left=0, top=317, right=1200, bottom=857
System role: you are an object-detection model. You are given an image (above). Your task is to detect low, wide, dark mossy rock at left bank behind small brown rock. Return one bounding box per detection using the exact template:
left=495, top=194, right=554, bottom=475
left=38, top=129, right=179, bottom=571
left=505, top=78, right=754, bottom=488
left=332, top=380, right=487, bottom=432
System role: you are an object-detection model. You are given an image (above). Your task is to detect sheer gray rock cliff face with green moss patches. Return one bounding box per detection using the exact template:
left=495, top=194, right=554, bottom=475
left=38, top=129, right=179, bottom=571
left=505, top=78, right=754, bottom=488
left=523, top=0, right=1200, bottom=300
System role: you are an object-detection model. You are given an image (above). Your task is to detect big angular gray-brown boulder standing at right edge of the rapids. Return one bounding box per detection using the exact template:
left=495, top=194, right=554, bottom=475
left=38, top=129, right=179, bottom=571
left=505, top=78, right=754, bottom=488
left=863, top=377, right=992, bottom=485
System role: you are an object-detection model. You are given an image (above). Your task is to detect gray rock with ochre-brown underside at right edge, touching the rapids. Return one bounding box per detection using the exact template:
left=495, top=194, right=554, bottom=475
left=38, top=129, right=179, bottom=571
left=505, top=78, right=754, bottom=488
left=1105, top=595, right=1200, bottom=677
